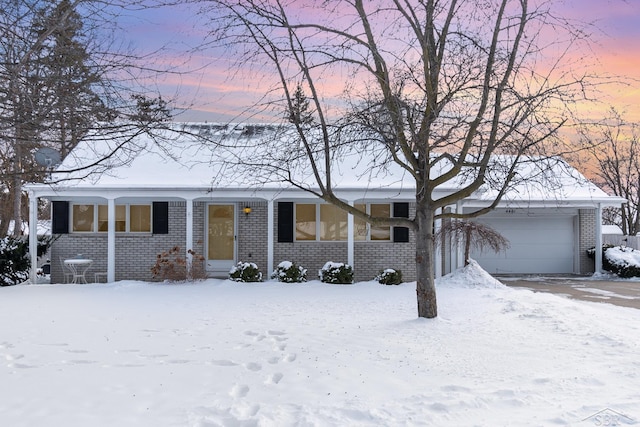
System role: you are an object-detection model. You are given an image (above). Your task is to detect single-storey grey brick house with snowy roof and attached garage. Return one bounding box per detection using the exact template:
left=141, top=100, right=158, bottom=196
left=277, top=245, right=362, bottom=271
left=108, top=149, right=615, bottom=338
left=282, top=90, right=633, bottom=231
left=26, top=124, right=623, bottom=283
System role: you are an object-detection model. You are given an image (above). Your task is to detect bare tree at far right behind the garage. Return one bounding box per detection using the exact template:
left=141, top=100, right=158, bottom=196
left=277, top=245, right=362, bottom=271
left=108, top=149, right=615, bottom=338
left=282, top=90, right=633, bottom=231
left=579, top=108, right=640, bottom=236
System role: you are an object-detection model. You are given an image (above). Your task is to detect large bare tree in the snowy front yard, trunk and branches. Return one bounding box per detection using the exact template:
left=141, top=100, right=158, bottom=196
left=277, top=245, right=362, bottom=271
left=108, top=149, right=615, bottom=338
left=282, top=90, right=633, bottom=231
left=201, top=0, right=586, bottom=318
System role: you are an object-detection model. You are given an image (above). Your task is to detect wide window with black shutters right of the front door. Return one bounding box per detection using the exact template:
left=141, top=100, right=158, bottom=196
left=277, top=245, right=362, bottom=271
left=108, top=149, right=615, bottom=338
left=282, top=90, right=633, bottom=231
left=295, top=203, right=391, bottom=241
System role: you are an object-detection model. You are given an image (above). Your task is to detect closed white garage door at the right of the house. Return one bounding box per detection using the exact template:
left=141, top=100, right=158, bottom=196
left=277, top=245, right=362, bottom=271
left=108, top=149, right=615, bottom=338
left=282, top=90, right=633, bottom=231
left=471, top=216, right=575, bottom=274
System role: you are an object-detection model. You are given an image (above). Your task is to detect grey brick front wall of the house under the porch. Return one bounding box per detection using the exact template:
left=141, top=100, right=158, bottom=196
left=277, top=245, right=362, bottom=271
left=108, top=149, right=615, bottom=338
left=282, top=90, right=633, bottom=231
left=51, top=201, right=415, bottom=283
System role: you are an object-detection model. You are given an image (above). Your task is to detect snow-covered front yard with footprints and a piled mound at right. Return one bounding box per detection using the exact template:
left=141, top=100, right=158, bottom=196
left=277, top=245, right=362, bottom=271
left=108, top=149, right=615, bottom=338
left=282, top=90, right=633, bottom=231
left=0, top=265, right=640, bottom=427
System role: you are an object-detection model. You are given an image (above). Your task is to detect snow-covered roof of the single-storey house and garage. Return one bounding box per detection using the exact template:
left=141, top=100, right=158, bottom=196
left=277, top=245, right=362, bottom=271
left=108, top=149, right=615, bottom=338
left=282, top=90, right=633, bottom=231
left=29, top=123, right=622, bottom=208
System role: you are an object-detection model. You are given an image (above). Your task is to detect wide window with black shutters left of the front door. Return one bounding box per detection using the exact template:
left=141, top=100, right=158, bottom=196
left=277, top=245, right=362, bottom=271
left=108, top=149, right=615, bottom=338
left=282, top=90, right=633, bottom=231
left=71, top=205, right=151, bottom=233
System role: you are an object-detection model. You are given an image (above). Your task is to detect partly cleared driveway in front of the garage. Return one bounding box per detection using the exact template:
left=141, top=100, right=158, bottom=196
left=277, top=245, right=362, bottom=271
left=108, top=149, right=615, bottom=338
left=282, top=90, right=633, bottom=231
left=498, top=277, right=640, bottom=309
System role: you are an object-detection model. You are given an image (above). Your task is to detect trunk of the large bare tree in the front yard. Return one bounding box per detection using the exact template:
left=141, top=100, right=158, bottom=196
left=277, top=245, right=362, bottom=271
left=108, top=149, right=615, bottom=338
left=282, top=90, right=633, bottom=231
left=416, top=204, right=438, bottom=319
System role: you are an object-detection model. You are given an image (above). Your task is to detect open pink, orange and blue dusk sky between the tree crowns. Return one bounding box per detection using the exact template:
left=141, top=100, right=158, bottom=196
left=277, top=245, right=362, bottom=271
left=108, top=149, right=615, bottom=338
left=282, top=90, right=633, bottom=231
left=116, top=0, right=640, bottom=125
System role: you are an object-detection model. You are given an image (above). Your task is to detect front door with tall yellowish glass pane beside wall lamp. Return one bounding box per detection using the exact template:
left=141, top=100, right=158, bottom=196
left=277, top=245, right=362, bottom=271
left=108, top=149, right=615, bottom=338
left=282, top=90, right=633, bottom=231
left=207, top=205, right=236, bottom=277
